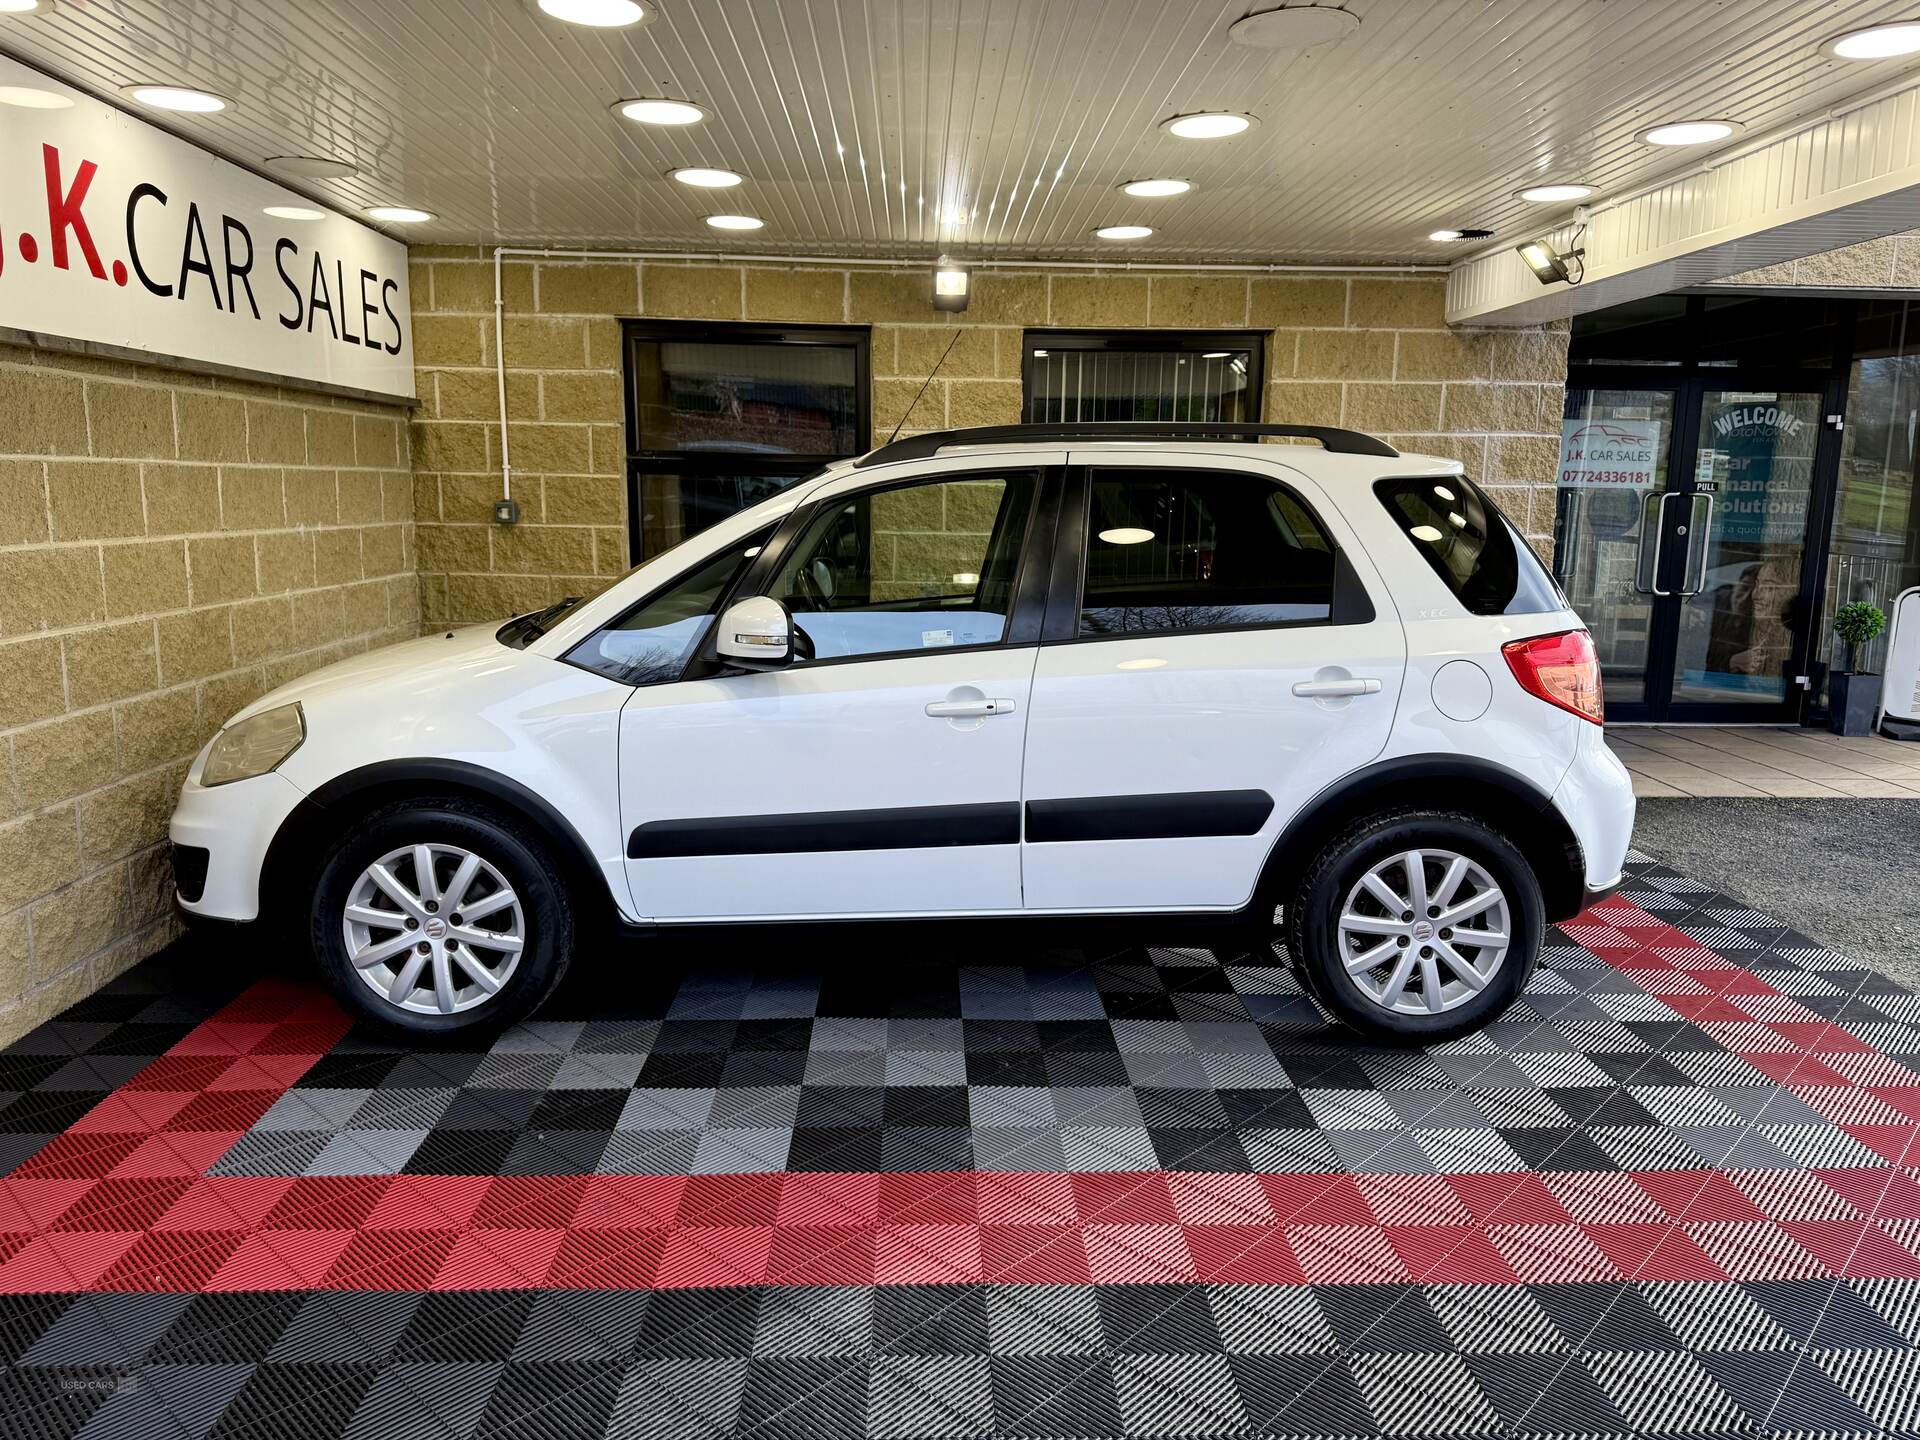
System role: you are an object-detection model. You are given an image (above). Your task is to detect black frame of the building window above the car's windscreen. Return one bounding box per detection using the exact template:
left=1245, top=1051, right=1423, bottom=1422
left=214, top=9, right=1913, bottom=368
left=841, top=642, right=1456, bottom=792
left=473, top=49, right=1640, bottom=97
left=620, top=321, right=874, bottom=564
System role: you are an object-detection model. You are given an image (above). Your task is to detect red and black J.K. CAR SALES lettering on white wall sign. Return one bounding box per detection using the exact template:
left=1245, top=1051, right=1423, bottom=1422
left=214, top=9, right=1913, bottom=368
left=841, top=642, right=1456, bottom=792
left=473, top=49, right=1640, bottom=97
left=0, top=144, right=405, bottom=355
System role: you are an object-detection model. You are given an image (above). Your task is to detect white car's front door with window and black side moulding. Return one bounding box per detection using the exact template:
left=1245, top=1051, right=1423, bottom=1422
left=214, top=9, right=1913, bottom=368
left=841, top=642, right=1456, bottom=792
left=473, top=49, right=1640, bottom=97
left=620, top=467, right=1052, bottom=920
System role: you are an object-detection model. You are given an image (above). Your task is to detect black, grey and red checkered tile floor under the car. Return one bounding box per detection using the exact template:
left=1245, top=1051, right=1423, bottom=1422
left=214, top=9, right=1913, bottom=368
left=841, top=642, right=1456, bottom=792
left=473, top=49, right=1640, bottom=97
left=0, top=862, right=1920, bottom=1440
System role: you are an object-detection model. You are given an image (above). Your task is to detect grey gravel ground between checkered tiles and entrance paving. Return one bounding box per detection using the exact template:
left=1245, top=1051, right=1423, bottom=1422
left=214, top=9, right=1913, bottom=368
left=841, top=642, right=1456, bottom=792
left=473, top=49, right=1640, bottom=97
left=1634, top=799, right=1920, bottom=989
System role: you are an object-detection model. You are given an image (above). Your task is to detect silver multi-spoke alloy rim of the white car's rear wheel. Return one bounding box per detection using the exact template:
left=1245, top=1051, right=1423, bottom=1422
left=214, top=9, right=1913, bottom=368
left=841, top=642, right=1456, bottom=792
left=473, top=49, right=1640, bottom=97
left=1338, top=851, right=1513, bottom=1016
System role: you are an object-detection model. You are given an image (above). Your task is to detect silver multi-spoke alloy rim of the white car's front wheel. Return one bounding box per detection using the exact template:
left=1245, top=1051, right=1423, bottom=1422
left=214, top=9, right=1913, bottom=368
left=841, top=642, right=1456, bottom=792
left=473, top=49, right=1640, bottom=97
left=342, top=845, right=526, bottom=1016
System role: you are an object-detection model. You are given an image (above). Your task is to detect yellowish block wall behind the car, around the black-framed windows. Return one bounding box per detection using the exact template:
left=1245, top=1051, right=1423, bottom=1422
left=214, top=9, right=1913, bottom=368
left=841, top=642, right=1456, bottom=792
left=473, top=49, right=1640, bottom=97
left=411, top=246, right=1567, bottom=624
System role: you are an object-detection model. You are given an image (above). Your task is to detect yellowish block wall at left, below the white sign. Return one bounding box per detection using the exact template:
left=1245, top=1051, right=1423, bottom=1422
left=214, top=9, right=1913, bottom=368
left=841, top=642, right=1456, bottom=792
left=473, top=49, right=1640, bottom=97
left=0, top=346, right=419, bottom=1043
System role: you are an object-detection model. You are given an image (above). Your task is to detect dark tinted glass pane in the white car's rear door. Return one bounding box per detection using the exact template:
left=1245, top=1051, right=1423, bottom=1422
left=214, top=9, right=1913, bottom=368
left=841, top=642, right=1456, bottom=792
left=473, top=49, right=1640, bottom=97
left=1079, top=470, right=1332, bottom=636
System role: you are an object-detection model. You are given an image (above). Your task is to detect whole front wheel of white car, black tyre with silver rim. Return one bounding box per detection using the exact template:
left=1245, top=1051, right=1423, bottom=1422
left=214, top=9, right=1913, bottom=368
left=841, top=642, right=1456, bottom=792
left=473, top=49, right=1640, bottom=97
left=309, top=797, right=574, bottom=1035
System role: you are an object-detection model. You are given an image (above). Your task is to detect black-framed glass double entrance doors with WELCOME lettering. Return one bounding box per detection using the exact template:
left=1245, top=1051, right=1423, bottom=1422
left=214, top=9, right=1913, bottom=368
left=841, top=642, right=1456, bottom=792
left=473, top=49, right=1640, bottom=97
left=1555, top=372, right=1839, bottom=724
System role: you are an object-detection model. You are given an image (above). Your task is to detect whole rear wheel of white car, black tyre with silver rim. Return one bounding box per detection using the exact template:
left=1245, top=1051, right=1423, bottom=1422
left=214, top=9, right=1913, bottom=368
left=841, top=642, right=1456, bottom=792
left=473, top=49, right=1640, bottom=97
left=1286, top=810, right=1546, bottom=1044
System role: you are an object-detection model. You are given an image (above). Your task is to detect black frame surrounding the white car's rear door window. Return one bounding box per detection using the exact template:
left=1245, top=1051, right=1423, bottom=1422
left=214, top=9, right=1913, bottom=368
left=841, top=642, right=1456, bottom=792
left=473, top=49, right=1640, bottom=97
left=1041, top=464, right=1377, bottom=645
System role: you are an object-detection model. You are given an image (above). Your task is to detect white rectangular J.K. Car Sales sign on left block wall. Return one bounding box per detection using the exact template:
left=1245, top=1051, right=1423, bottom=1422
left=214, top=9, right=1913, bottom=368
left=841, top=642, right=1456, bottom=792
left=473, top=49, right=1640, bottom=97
left=0, top=56, right=413, bottom=399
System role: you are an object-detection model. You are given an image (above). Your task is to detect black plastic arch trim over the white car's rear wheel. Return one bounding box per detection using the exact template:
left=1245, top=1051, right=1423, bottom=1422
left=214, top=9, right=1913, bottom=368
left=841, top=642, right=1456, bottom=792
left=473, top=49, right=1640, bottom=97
left=1250, top=755, right=1586, bottom=920
